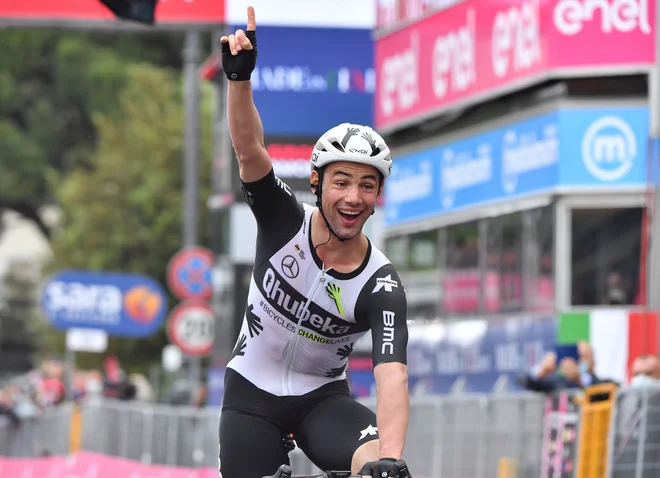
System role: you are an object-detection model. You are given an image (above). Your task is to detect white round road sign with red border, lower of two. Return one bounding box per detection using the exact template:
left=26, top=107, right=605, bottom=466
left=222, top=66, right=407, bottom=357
left=167, top=301, right=215, bottom=356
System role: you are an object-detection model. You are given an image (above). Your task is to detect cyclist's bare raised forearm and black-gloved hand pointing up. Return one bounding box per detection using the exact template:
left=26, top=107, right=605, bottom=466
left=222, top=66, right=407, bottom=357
left=220, top=7, right=272, bottom=183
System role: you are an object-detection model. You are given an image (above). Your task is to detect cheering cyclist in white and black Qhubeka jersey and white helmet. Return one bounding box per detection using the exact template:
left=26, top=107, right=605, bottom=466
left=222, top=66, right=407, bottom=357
left=220, top=7, right=409, bottom=478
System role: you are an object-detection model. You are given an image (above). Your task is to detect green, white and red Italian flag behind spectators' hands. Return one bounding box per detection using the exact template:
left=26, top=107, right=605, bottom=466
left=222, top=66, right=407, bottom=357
left=557, top=309, right=658, bottom=384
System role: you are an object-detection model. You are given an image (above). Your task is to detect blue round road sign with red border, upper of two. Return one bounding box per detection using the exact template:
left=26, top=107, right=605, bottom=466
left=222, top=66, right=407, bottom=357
left=167, top=247, right=214, bottom=300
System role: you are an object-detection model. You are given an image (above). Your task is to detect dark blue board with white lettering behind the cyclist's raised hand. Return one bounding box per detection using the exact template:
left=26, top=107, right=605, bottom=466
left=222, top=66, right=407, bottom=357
left=229, top=25, right=376, bottom=138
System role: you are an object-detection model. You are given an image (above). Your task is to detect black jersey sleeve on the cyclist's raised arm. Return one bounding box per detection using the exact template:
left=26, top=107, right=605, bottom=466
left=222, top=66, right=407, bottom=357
left=241, top=169, right=305, bottom=240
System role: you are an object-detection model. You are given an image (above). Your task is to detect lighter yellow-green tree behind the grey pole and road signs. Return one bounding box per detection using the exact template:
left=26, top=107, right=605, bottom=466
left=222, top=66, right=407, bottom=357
left=43, top=60, right=212, bottom=372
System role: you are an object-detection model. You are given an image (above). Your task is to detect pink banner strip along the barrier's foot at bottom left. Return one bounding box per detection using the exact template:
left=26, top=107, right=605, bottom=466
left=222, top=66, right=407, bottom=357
left=0, top=452, right=218, bottom=478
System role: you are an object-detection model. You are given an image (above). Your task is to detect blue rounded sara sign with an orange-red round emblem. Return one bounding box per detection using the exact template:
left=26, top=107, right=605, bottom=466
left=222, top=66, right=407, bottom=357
left=41, top=271, right=167, bottom=337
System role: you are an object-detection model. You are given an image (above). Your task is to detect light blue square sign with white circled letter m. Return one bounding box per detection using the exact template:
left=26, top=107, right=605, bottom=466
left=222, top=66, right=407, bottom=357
left=560, top=107, right=649, bottom=186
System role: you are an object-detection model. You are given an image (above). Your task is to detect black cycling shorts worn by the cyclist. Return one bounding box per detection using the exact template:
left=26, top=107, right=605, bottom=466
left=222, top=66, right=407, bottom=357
left=220, top=369, right=378, bottom=478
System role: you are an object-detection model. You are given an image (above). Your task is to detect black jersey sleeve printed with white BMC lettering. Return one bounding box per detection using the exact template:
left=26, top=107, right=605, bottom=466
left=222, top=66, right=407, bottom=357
left=356, top=264, right=408, bottom=367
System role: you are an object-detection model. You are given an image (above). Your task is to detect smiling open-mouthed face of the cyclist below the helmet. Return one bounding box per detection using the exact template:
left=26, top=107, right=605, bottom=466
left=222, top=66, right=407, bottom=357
left=310, top=161, right=382, bottom=240
